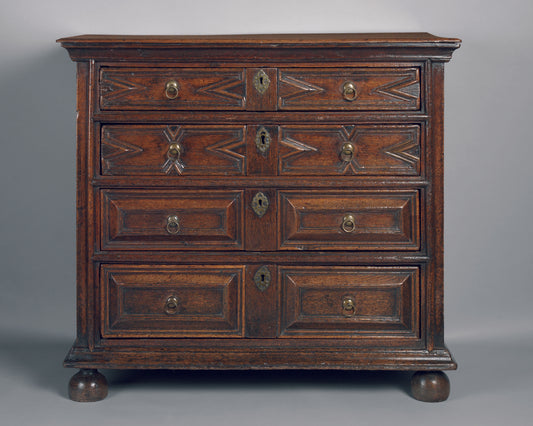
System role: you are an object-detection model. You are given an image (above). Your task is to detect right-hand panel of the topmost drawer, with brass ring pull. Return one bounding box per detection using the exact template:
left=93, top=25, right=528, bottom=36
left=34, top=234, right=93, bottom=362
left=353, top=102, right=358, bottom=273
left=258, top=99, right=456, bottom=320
left=278, top=67, right=421, bottom=111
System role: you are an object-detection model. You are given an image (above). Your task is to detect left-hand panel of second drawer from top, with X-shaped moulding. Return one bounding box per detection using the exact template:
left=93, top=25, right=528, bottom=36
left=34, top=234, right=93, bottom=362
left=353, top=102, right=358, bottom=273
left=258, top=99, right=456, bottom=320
left=100, top=125, right=246, bottom=176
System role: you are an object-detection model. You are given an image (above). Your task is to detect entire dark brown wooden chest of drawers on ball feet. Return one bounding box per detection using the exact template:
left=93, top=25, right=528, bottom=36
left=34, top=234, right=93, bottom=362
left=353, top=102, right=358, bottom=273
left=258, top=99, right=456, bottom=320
left=59, top=33, right=460, bottom=401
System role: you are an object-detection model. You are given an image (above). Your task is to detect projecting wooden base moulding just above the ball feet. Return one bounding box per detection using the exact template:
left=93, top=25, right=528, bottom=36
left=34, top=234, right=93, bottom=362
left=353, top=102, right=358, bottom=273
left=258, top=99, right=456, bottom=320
left=65, top=348, right=456, bottom=371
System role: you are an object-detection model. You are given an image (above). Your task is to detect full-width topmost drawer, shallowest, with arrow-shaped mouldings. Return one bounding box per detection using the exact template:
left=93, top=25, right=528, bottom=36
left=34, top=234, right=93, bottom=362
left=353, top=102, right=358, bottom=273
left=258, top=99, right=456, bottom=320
left=99, top=67, right=422, bottom=111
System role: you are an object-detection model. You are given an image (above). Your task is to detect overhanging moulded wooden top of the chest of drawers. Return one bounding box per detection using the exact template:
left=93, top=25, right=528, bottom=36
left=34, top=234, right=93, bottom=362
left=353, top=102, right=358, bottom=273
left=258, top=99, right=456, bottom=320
left=57, top=32, right=461, bottom=61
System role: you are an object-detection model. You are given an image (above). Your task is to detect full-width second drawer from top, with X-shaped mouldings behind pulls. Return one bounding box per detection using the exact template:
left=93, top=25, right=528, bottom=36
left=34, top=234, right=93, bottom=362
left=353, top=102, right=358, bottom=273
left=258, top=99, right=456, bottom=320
left=100, top=124, right=421, bottom=176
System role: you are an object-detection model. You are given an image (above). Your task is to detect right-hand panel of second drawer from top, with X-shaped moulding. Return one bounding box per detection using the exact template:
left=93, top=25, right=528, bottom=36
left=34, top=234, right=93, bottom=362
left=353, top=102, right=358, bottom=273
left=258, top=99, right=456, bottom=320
left=278, top=124, right=421, bottom=176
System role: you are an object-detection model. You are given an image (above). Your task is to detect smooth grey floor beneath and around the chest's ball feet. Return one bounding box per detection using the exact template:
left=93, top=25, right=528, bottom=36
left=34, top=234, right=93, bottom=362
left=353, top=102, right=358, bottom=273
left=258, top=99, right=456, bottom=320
left=0, top=330, right=533, bottom=426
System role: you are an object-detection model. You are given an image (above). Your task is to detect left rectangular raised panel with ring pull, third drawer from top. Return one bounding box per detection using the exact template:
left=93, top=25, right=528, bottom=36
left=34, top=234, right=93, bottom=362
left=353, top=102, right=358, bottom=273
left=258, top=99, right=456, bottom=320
left=101, top=189, right=243, bottom=250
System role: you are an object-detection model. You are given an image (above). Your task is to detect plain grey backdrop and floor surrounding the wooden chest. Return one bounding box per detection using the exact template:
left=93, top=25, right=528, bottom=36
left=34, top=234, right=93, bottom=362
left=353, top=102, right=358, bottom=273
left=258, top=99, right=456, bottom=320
left=0, top=0, right=533, bottom=425
